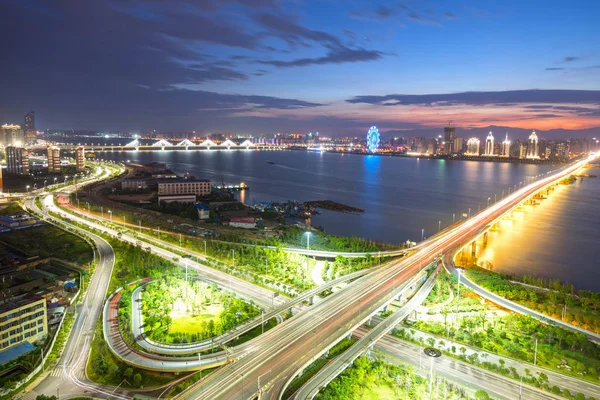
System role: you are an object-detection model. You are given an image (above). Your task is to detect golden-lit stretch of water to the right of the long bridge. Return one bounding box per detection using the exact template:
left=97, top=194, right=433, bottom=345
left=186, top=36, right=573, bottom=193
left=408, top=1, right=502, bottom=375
left=477, top=178, right=600, bottom=290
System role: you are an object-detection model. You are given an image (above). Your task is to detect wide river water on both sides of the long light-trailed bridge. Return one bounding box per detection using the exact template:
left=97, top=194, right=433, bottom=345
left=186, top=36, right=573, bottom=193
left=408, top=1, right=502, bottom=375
left=98, top=151, right=600, bottom=290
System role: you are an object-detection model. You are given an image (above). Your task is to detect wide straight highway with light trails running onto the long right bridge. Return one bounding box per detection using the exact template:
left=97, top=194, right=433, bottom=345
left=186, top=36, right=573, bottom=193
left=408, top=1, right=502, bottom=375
left=180, top=158, right=591, bottom=399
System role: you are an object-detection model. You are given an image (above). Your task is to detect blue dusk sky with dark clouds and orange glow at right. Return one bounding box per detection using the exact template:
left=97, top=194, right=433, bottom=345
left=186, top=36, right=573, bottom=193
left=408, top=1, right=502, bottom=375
left=0, top=0, right=600, bottom=135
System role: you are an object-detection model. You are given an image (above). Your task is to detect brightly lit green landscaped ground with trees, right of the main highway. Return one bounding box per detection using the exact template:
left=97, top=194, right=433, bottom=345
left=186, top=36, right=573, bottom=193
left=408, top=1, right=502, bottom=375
left=394, top=266, right=600, bottom=398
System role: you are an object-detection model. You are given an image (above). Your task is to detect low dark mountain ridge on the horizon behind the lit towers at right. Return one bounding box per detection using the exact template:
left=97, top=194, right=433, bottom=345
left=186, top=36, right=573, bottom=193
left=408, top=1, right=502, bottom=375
left=381, top=125, right=600, bottom=140
